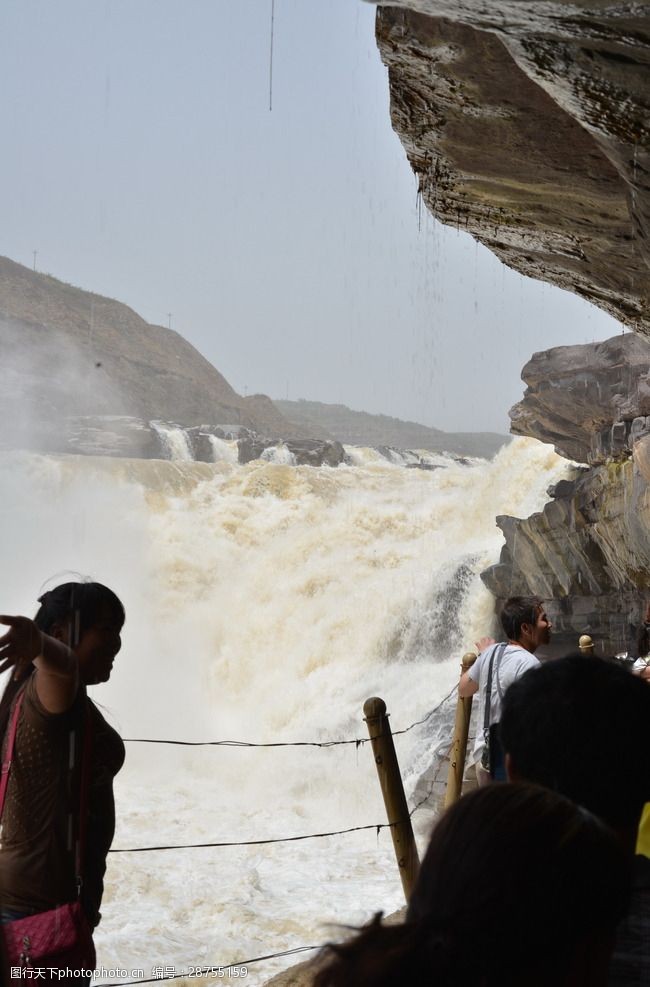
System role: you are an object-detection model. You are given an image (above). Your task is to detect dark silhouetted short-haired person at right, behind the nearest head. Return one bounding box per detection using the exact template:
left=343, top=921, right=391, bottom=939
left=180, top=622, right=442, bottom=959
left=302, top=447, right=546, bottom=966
left=500, top=655, right=650, bottom=987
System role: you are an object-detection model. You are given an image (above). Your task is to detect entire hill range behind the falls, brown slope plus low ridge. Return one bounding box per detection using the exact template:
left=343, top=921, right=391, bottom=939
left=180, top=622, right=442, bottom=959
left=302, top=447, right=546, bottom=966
left=0, top=257, right=508, bottom=457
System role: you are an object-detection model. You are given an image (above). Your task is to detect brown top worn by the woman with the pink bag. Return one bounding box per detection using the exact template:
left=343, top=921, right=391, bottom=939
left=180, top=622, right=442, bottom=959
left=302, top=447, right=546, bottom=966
left=0, top=675, right=124, bottom=926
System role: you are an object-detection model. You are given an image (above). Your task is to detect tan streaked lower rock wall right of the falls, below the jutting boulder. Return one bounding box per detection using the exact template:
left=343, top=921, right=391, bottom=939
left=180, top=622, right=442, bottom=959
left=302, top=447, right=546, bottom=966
left=482, top=454, right=650, bottom=654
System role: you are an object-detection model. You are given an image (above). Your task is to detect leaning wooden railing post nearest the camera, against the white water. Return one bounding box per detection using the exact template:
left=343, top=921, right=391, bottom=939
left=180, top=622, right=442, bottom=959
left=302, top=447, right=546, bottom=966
left=363, top=696, right=420, bottom=902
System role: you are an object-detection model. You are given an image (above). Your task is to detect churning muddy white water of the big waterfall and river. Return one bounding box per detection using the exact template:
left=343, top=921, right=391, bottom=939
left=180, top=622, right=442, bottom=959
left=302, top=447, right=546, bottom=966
left=0, top=439, right=567, bottom=987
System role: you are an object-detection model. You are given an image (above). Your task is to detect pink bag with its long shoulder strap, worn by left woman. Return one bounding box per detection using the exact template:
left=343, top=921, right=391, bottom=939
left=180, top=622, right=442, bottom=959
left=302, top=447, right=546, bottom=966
left=0, top=693, right=96, bottom=985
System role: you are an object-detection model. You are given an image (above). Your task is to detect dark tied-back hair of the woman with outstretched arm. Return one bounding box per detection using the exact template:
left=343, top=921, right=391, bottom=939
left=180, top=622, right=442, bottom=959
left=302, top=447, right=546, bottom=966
left=0, top=582, right=125, bottom=739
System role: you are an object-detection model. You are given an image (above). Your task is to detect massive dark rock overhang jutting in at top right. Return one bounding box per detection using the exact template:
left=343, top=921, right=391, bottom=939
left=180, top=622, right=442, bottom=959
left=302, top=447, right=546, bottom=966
left=370, top=0, right=650, bottom=334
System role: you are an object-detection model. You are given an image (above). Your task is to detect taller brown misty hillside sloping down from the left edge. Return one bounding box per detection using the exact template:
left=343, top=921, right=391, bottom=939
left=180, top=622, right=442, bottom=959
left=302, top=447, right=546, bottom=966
left=0, top=257, right=296, bottom=436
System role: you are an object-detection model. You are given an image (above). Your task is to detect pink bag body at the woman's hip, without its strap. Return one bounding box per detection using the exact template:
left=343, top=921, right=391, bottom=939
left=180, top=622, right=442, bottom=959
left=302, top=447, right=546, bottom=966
left=0, top=901, right=95, bottom=983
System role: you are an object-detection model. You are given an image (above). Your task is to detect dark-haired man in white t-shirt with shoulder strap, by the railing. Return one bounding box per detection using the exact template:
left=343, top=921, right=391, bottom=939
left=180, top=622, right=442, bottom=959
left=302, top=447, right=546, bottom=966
left=458, top=596, right=552, bottom=785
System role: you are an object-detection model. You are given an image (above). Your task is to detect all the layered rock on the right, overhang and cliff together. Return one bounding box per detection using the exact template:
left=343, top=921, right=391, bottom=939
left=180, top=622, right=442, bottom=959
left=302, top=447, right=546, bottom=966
left=368, top=0, right=650, bottom=653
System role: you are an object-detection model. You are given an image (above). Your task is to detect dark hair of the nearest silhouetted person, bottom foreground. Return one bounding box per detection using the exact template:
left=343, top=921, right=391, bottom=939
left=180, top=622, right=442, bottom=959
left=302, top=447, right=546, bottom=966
left=314, top=784, right=629, bottom=987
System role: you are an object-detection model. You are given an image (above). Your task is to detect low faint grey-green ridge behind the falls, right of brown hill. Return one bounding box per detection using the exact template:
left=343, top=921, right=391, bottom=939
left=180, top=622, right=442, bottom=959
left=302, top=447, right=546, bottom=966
left=274, top=399, right=510, bottom=459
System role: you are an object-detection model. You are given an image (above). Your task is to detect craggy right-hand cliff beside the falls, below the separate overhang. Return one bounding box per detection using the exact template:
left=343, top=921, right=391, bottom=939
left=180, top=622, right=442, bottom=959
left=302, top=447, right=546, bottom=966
left=483, top=334, right=650, bottom=653
